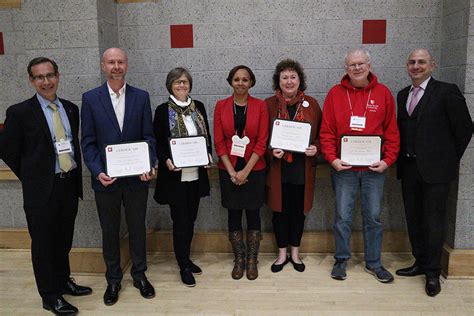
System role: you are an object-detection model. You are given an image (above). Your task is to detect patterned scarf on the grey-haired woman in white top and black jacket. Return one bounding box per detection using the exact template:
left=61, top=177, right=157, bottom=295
left=168, top=98, right=209, bottom=146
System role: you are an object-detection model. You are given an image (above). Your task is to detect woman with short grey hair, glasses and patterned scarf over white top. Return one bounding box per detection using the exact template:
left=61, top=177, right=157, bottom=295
left=153, top=67, right=212, bottom=287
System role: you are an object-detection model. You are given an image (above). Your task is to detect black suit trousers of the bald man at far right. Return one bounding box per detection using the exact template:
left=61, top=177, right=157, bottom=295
left=402, top=158, right=449, bottom=278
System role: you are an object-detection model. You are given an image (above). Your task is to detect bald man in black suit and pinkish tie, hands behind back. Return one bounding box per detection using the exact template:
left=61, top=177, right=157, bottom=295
left=396, top=49, right=472, bottom=296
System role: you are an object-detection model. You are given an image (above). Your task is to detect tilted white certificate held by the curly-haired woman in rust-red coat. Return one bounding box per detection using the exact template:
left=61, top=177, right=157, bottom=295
left=269, top=119, right=311, bottom=153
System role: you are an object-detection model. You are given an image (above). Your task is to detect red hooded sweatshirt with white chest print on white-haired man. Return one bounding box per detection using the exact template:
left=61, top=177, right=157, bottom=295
left=319, top=73, right=400, bottom=171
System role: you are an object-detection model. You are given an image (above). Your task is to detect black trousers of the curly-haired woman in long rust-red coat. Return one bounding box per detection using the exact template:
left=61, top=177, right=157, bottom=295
left=272, top=183, right=306, bottom=248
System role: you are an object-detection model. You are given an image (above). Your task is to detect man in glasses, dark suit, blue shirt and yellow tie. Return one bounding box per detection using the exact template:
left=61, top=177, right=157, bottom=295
left=0, top=57, right=92, bottom=314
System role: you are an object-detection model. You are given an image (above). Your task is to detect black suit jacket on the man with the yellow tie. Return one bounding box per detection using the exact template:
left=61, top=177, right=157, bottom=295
left=0, top=95, right=82, bottom=207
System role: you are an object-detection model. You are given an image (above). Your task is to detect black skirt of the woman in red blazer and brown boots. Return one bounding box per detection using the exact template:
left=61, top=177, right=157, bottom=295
left=219, top=169, right=266, bottom=210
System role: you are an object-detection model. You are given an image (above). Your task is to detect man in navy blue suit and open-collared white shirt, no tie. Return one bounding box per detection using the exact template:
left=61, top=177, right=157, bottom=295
left=81, top=48, right=156, bottom=305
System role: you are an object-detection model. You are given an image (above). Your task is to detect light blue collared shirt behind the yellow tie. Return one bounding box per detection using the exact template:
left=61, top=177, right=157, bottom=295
left=36, top=93, right=77, bottom=173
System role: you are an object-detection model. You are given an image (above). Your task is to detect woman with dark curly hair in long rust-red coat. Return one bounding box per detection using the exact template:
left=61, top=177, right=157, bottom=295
left=265, top=59, right=321, bottom=272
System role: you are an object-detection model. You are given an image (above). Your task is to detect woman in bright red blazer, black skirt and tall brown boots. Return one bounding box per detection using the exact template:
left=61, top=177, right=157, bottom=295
left=214, top=65, right=268, bottom=280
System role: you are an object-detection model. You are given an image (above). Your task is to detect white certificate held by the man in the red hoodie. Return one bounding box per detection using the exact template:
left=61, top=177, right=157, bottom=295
left=341, top=135, right=382, bottom=167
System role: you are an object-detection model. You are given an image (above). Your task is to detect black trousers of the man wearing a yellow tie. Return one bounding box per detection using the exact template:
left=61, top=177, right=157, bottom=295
left=25, top=172, right=78, bottom=302
